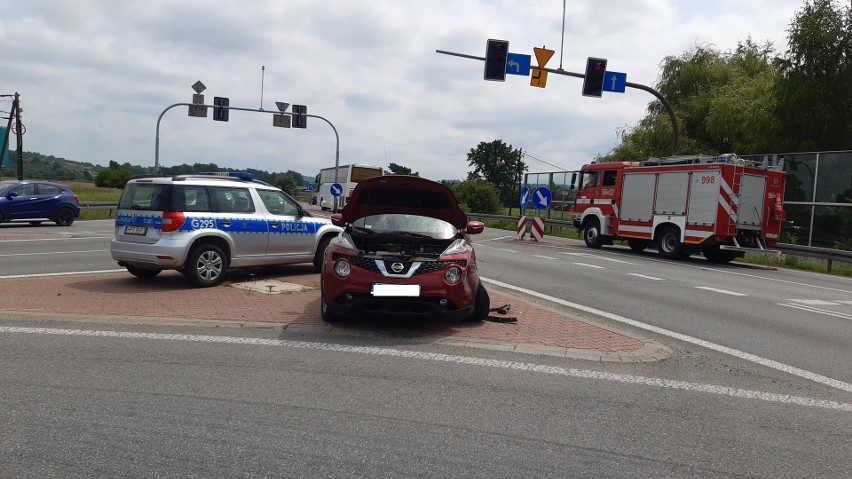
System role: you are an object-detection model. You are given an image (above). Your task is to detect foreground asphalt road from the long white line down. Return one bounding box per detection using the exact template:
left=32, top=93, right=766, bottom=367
left=0, top=322, right=852, bottom=478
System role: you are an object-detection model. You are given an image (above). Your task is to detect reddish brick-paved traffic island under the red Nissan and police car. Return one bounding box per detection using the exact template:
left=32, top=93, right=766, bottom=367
left=0, top=265, right=671, bottom=361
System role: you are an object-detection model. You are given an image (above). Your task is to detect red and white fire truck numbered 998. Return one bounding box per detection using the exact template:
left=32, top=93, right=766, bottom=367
left=574, top=153, right=786, bottom=263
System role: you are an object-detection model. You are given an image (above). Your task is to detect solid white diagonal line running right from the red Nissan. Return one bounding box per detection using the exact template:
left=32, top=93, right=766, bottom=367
left=480, top=276, right=852, bottom=392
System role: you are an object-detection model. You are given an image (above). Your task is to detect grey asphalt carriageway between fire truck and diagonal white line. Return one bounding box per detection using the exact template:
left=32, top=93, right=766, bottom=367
left=476, top=231, right=852, bottom=384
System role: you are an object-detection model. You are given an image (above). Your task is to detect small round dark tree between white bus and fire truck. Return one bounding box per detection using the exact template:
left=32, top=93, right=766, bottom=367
left=467, top=140, right=527, bottom=205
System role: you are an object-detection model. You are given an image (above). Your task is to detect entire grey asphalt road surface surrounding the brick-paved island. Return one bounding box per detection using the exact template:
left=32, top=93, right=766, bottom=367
left=0, top=221, right=852, bottom=478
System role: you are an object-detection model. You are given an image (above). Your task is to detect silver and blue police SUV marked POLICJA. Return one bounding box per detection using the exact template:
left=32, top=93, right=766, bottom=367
left=110, top=173, right=342, bottom=287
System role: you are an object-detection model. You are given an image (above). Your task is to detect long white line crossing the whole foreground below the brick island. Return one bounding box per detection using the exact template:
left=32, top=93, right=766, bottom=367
left=0, top=326, right=852, bottom=412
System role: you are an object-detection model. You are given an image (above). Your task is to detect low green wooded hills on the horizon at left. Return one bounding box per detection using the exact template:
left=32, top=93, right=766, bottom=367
left=0, top=151, right=314, bottom=186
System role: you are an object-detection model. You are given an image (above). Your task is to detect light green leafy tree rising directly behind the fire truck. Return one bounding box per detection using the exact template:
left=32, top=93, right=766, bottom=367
left=599, top=38, right=780, bottom=161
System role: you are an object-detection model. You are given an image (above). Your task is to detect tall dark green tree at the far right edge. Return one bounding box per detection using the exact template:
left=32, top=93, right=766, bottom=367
left=775, top=0, right=852, bottom=151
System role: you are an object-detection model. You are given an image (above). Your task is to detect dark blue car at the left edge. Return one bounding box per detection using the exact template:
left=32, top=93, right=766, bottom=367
left=0, top=180, right=80, bottom=226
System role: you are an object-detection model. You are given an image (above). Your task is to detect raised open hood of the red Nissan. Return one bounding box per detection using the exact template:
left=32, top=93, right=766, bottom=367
left=340, top=175, right=467, bottom=230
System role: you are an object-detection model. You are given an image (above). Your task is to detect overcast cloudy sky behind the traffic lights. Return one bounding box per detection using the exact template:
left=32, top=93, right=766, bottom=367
left=0, top=0, right=802, bottom=180
